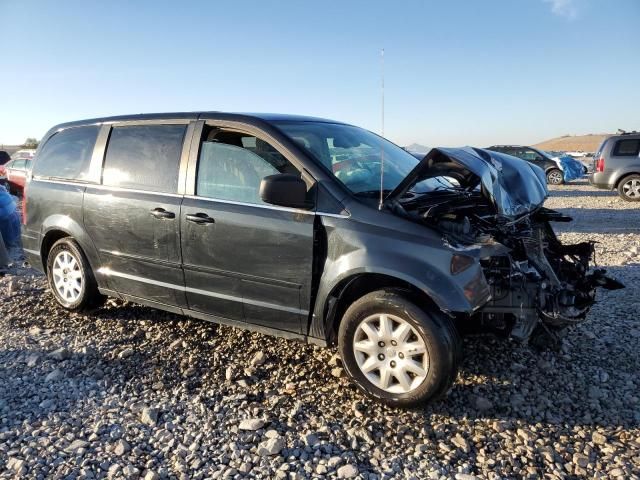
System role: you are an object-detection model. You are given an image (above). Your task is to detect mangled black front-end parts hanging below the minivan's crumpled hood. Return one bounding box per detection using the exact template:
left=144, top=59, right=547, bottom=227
left=472, top=208, right=622, bottom=341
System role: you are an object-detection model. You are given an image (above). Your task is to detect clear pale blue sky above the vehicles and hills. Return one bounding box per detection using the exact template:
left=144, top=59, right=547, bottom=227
left=0, top=0, right=640, bottom=147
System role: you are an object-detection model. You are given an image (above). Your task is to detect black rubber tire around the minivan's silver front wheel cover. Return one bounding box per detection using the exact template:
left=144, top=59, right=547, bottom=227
left=338, top=290, right=462, bottom=407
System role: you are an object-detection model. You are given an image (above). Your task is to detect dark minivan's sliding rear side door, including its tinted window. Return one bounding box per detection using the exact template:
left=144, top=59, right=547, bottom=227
left=84, top=122, right=187, bottom=307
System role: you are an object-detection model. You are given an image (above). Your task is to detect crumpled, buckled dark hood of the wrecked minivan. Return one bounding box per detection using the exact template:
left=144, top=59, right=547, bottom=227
left=385, top=147, right=549, bottom=217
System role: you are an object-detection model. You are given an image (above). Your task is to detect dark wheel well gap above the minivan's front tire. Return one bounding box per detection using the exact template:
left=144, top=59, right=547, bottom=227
left=324, top=273, right=439, bottom=345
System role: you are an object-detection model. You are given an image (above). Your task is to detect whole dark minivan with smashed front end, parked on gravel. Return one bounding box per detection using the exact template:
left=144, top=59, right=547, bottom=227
left=22, top=113, right=619, bottom=406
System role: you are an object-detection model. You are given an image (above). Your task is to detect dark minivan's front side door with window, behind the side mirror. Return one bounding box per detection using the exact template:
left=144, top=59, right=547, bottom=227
left=180, top=125, right=314, bottom=333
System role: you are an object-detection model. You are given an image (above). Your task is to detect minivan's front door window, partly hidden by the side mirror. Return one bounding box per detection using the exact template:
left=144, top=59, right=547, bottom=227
left=196, top=128, right=300, bottom=205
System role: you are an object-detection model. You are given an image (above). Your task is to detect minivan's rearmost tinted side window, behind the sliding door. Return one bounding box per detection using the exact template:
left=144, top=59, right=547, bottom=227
left=33, top=125, right=100, bottom=180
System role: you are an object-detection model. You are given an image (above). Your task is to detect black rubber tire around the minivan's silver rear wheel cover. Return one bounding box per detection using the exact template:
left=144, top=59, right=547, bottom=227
left=47, top=237, right=106, bottom=311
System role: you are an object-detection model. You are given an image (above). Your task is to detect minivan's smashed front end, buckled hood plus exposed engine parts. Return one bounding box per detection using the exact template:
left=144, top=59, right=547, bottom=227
left=382, top=149, right=623, bottom=341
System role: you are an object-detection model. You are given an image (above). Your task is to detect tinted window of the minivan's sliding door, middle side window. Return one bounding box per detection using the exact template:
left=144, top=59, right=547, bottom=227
left=102, top=125, right=187, bottom=193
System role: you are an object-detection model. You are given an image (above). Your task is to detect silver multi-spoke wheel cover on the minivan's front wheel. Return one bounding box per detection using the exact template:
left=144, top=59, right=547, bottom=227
left=353, top=313, right=429, bottom=393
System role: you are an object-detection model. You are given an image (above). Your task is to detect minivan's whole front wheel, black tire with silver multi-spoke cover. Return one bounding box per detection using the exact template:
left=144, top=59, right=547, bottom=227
left=338, top=290, right=461, bottom=407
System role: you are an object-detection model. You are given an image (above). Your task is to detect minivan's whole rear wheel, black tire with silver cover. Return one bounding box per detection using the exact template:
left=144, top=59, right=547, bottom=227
left=47, top=237, right=106, bottom=310
